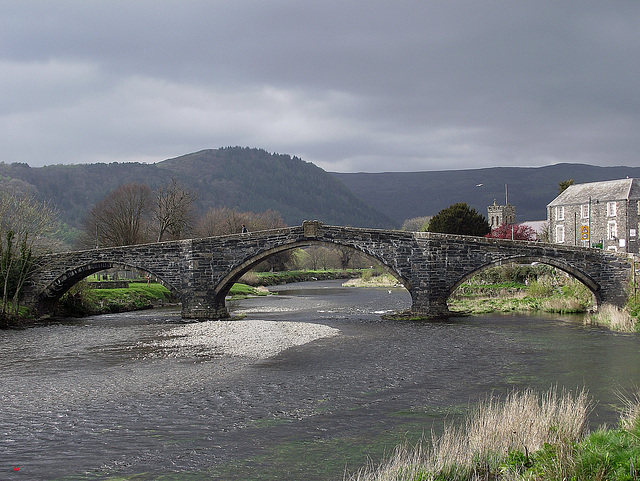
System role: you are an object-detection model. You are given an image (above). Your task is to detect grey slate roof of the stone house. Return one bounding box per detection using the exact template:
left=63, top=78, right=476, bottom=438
left=547, top=179, right=640, bottom=207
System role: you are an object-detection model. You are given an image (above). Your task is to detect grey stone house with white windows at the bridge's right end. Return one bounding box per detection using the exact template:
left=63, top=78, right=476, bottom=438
left=547, top=179, right=640, bottom=254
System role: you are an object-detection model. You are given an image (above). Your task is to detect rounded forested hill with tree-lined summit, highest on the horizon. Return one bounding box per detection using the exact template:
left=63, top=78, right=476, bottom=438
left=156, top=147, right=393, bottom=227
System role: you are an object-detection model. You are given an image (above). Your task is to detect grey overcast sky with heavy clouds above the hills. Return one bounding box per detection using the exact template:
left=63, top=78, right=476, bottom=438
left=0, top=0, right=640, bottom=172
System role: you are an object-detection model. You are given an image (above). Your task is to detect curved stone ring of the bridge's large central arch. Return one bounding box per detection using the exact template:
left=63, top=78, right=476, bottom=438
left=214, top=239, right=410, bottom=302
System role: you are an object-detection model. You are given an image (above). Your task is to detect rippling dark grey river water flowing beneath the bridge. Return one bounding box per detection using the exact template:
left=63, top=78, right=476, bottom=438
left=0, top=281, right=640, bottom=481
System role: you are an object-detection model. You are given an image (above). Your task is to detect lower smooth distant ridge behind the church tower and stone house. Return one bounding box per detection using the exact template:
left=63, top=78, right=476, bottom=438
left=333, top=164, right=640, bottom=226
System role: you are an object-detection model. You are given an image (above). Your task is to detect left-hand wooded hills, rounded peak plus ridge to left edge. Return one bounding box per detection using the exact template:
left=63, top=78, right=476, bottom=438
left=0, top=147, right=394, bottom=232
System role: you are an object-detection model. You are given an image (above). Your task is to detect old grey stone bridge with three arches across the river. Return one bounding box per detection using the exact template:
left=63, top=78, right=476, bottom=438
left=25, top=221, right=633, bottom=319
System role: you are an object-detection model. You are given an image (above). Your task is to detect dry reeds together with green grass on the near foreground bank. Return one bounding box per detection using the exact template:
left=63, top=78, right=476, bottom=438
left=345, top=388, right=640, bottom=481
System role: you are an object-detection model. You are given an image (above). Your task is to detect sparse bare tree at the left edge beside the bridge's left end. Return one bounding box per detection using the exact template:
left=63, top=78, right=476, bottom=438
left=0, top=190, right=57, bottom=319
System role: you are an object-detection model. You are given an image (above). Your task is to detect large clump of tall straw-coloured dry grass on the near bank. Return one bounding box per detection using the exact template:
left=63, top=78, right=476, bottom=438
left=349, top=388, right=591, bottom=481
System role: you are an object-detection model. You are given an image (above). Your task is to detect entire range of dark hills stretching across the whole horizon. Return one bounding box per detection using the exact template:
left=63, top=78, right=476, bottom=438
left=0, top=147, right=640, bottom=236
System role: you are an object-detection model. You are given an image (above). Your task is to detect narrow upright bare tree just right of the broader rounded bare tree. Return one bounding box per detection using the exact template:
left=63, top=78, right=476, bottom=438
left=153, top=177, right=196, bottom=242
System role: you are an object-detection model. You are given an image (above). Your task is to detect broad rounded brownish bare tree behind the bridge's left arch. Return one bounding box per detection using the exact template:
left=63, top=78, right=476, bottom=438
left=83, top=183, right=153, bottom=248
